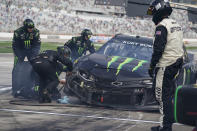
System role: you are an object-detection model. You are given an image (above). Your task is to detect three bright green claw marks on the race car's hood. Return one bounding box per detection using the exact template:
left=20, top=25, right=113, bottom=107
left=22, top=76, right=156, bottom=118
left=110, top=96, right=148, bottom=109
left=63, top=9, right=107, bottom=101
left=107, top=56, right=148, bottom=75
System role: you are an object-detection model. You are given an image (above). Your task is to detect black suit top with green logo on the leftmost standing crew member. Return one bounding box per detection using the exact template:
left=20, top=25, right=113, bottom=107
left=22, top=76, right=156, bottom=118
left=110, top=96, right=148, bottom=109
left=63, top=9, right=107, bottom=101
left=12, top=26, right=41, bottom=65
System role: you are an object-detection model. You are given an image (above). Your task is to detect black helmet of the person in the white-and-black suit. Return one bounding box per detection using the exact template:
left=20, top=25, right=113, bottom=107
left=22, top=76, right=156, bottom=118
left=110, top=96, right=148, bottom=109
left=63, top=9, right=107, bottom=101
left=147, top=0, right=172, bottom=25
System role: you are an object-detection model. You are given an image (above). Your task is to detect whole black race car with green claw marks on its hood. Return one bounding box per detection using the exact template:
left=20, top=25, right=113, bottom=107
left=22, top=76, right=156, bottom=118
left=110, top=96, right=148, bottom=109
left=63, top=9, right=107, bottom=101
left=65, top=34, right=193, bottom=110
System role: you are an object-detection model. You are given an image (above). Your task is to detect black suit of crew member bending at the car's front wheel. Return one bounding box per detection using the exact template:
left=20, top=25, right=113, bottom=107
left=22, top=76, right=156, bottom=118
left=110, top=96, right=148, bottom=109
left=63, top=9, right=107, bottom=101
left=30, top=50, right=73, bottom=102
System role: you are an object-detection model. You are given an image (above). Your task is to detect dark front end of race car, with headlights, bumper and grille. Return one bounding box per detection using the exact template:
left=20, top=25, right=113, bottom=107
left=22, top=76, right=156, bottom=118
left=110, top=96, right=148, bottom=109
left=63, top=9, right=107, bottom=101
left=67, top=71, right=158, bottom=110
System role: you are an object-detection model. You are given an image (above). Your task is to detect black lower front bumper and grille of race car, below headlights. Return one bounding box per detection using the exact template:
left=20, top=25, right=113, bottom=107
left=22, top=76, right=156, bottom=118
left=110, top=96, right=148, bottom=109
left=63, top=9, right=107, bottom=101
left=67, top=77, right=158, bottom=110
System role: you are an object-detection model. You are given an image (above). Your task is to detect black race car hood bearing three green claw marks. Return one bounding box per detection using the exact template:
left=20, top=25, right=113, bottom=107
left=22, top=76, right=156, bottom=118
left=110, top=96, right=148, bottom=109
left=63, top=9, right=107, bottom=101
left=76, top=53, right=149, bottom=81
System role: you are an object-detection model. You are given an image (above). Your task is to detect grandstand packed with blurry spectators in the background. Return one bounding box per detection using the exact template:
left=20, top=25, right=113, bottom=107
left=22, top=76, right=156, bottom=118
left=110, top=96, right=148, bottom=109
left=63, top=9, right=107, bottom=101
left=0, top=0, right=197, bottom=39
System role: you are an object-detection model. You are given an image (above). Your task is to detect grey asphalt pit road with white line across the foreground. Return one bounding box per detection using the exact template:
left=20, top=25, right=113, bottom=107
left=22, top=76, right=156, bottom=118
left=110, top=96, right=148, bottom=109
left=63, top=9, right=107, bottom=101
left=0, top=54, right=193, bottom=131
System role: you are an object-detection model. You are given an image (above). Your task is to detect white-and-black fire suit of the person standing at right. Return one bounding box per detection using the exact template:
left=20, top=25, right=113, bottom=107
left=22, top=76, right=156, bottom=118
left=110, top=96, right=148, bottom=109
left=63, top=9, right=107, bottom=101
left=149, top=18, right=183, bottom=131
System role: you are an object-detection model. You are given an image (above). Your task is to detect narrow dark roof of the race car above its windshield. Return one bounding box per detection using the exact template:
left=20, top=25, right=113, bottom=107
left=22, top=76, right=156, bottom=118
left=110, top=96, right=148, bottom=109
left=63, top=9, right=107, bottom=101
left=112, top=34, right=153, bottom=45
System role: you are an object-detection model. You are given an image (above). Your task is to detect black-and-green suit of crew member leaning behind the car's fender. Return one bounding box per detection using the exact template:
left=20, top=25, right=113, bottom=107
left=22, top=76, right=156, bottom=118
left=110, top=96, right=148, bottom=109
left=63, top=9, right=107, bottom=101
left=65, top=36, right=95, bottom=61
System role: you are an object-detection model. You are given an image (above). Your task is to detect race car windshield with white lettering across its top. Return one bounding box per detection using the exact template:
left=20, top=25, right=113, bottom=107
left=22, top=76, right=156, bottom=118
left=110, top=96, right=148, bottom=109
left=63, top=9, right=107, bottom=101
left=97, top=36, right=152, bottom=61
